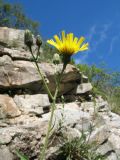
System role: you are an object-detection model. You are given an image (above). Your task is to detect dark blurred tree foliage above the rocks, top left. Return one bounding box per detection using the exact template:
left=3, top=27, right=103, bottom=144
left=0, top=0, right=39, bottom=34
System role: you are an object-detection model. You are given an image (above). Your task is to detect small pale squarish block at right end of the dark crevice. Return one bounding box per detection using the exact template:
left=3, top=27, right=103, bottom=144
left=76, top=83, right=92, bottom=94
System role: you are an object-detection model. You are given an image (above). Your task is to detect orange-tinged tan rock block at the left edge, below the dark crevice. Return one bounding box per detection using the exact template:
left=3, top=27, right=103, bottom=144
left=0, top=95, right=21, bottom=119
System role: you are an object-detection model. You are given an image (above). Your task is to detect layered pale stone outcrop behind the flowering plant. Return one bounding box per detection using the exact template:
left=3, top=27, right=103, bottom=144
left=0, top=28, right=120, bottom=160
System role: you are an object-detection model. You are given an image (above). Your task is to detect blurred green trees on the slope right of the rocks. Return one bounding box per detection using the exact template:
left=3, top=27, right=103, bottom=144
left=77, top=64, right=120, bottom=114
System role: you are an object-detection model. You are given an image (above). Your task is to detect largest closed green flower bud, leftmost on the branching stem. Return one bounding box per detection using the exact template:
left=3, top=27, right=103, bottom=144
left=24, top=30, right=33, bottom=47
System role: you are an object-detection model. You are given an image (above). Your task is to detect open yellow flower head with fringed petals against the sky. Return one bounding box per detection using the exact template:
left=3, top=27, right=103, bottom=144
left=47, top=31, right=88, bottom=55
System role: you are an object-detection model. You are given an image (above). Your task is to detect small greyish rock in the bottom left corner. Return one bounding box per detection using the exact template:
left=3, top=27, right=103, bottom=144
left=0, top=145, right=13, bottom=160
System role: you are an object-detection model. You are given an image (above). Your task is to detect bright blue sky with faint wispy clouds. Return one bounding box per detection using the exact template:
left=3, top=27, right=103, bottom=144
left=7, top=0, right=120, bottom=71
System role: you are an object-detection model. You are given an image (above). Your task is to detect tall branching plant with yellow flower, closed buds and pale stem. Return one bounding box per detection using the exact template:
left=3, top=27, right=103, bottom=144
left=24, top=30, right=88, bottom=160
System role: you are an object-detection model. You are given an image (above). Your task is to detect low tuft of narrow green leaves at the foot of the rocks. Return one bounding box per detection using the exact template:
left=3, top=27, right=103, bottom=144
left=57, top=134, right=105, bottom=160
